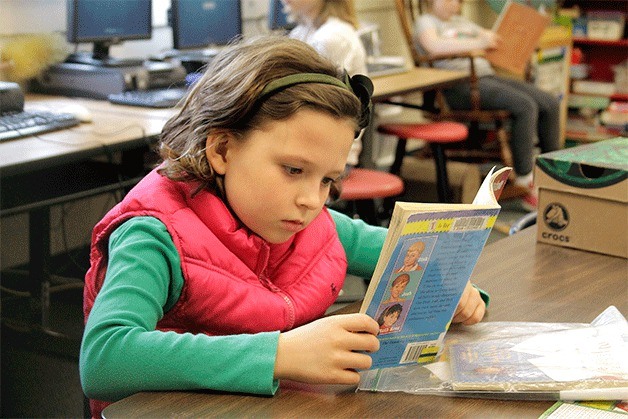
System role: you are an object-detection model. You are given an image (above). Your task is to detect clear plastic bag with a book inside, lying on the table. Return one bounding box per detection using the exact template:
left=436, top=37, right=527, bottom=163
left=358, top=306, right=628, bottom=400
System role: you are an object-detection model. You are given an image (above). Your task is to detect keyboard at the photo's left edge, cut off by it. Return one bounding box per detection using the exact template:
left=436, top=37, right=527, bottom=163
left=0, top=111, right=81, bottom=141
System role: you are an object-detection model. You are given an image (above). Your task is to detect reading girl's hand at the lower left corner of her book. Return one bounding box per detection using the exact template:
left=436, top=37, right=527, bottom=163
left=275, top=314, right=379, bottom=384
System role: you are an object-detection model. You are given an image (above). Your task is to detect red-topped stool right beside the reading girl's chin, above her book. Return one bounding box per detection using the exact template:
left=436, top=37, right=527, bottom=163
left=339, top=168, right=404, bottom=225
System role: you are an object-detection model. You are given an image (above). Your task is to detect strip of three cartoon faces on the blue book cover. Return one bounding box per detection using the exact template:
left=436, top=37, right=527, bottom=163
left=375, top=236, right=437, bottom=335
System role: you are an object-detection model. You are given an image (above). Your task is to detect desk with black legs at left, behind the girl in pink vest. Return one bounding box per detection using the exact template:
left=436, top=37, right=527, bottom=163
left=0, top=95, right=174, bottom=337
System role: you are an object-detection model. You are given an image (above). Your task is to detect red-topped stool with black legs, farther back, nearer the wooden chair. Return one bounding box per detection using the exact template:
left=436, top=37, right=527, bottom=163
left=377, top=121, right=469, bottom=202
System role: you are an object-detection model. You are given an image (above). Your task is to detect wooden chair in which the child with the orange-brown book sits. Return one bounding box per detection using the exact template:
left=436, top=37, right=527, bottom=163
left=389, top=0, right=512, bottom=166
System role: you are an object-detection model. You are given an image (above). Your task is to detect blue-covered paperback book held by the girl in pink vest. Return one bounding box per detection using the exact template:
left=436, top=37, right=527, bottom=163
left=360, top=168, right=510, bottom=368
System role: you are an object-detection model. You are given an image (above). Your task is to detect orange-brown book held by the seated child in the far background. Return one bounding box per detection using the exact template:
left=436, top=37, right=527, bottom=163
left=486, top=1, right=550, bottom=76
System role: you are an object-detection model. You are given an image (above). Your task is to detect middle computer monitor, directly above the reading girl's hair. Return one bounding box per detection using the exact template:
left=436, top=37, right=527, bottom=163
left=170, top=0, right=242, bottom=51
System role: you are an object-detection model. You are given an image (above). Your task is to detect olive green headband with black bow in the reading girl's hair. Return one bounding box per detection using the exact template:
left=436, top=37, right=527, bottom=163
left=257, top=71, right=373, bottom=135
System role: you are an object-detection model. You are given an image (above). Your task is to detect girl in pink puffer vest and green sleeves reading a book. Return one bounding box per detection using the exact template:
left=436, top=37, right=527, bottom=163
left=79, top=37, right=485, bottom=417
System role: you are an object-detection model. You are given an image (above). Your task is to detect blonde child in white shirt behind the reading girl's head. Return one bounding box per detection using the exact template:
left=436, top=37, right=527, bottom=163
left=281, top=0, right=367, bottom=166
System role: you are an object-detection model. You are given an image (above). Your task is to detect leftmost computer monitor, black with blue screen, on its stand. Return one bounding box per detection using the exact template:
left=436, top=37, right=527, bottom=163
left=66, top=0, right=152, bottom=66
